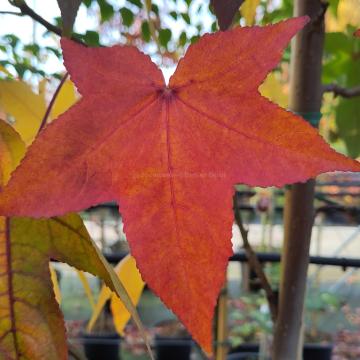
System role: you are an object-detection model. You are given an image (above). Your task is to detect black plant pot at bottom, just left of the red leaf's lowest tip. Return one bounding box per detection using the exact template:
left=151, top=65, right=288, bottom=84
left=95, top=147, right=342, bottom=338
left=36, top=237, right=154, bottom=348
left=155, top=335, right=192, bottom=360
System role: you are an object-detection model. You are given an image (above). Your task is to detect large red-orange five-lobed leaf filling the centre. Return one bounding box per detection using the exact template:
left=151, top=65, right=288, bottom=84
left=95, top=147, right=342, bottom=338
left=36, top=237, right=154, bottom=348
left=0, top=17, right=360, bottom=352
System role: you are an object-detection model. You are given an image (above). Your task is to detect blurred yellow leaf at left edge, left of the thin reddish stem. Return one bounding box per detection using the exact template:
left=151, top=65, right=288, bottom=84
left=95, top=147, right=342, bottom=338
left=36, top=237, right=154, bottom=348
left=0, top=80, right=46, bottom=145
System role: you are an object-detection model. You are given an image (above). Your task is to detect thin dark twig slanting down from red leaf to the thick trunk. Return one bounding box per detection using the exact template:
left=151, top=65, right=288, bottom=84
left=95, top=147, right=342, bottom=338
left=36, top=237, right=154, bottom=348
left=234, top=193, right=277, bottom=323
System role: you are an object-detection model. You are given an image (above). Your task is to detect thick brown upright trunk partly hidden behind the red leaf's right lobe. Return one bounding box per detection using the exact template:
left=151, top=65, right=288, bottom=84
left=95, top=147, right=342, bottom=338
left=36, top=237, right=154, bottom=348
left=273, top=0, right=326, bottom=360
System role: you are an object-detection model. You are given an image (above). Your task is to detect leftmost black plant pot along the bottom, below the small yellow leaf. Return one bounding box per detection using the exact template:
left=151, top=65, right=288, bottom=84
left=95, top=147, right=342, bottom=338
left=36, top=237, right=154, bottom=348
left=83, top=333, right=120, bottom=360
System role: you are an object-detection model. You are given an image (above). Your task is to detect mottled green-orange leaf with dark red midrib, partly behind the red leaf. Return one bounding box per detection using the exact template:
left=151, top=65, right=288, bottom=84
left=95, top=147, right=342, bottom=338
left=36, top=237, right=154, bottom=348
left=0, top=121, right=150, bottom=360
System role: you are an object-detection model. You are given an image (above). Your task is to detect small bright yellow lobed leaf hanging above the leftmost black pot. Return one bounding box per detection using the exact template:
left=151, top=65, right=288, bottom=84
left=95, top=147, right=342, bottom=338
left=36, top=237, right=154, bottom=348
left=87, top=255, right=145, bottom=334
